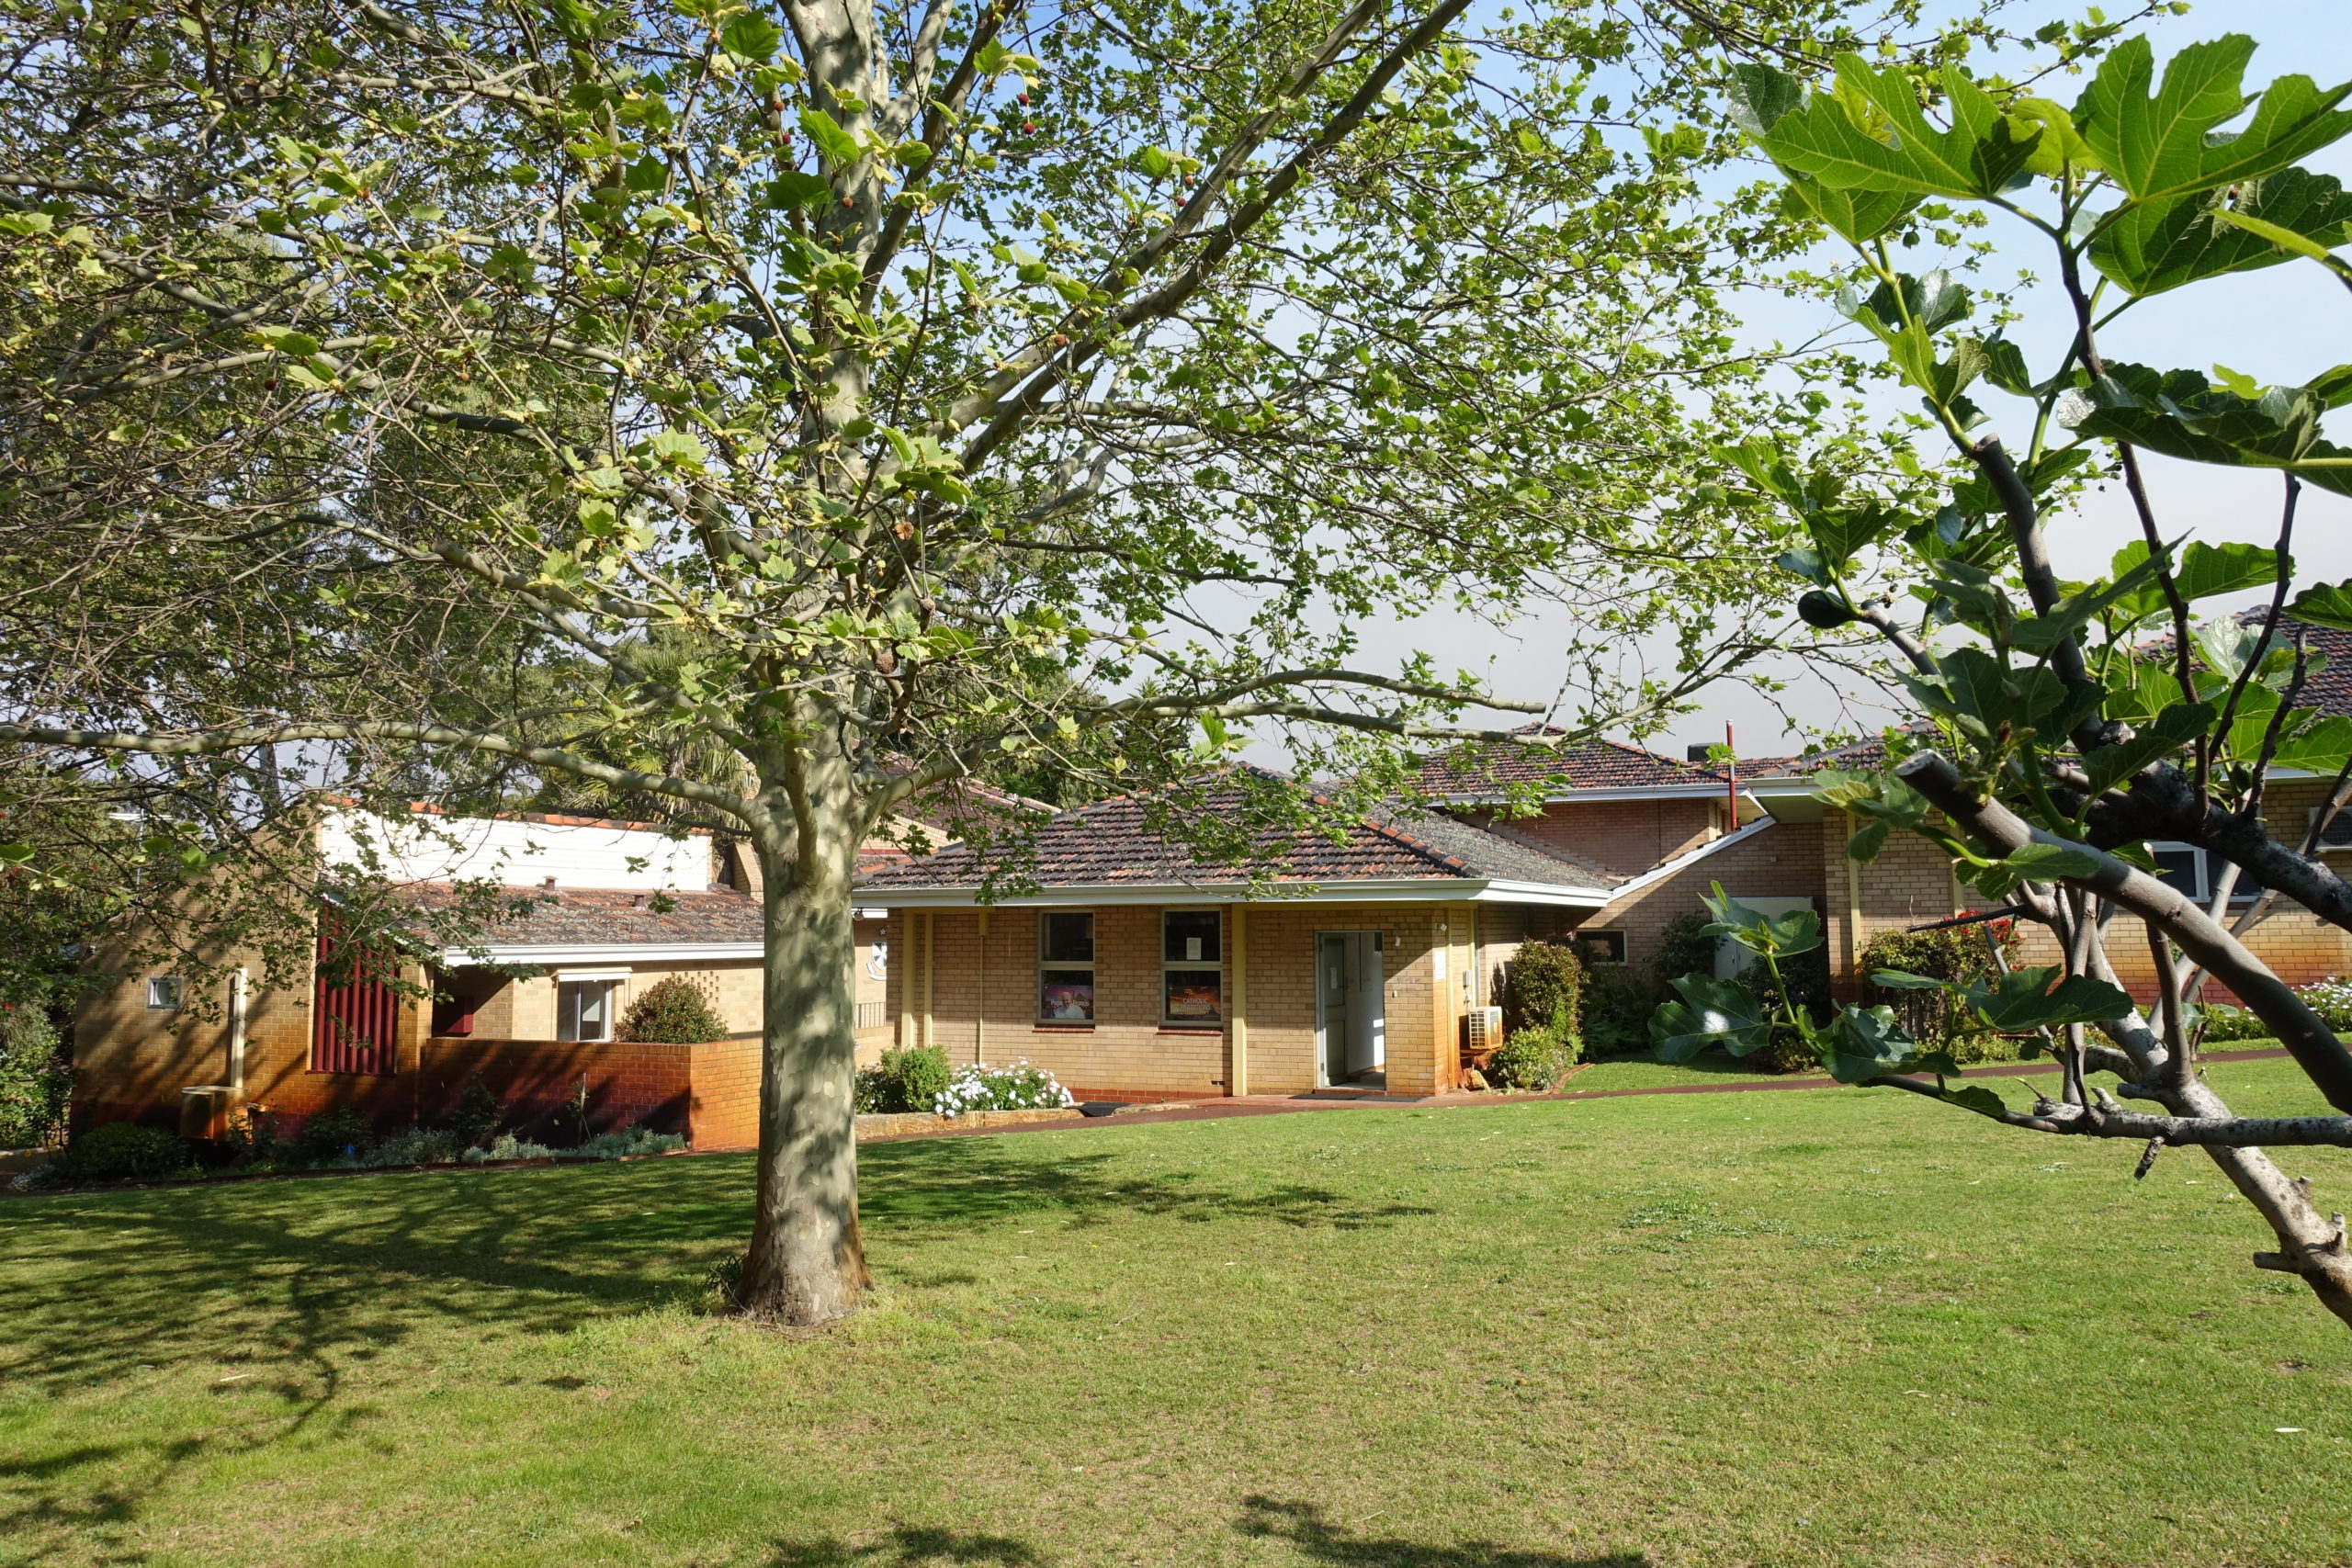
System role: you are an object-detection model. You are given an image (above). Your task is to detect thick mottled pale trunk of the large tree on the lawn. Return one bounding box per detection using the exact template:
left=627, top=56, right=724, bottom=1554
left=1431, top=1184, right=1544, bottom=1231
left=736, top=764, right=870, bottom=1325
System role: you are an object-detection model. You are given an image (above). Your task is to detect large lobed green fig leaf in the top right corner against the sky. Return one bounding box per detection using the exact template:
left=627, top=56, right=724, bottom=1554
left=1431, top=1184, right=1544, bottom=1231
left=2075, top=33, right=2352, bottom=202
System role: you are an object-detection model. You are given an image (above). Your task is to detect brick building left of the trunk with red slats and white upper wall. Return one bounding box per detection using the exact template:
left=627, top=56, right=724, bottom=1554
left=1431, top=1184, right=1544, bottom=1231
left=73, top=808, right=894, bottom=1147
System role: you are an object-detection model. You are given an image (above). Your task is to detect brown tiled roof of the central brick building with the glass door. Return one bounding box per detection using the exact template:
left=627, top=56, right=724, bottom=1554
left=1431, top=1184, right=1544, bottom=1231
left=858, top=787, right=1609, bottom=894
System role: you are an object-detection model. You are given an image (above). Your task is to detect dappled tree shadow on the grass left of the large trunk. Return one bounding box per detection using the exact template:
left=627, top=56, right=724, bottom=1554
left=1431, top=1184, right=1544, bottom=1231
left=0, top=1161, right=751, bottom=1392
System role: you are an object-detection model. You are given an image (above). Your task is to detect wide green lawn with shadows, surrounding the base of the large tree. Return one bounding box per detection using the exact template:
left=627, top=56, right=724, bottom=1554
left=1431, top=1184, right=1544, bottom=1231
left=0, top=1063, right=2352, bottom=1568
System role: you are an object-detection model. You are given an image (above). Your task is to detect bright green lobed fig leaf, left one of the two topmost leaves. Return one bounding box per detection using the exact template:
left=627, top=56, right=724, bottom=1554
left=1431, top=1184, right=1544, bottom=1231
left=1761, top=54, right=2041, bottom=197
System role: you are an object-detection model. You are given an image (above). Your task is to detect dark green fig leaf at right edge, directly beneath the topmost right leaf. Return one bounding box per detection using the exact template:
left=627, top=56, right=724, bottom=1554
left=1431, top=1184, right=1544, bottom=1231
left=2091, top=169, right=2352, bottom=296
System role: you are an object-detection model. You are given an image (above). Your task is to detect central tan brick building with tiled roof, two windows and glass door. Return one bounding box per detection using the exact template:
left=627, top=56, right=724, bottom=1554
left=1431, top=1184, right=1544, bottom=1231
left=858, top=792, right=1609, bottom=1100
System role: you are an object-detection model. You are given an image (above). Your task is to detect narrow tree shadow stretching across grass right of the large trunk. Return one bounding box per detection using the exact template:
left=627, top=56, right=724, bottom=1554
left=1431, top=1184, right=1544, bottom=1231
left=858, top=1138, right=1437, bottom=1232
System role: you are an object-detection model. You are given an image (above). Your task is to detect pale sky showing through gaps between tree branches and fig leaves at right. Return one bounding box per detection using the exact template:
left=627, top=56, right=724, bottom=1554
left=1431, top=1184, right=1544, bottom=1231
left=1317, top=0, right=2352, bottom=755
